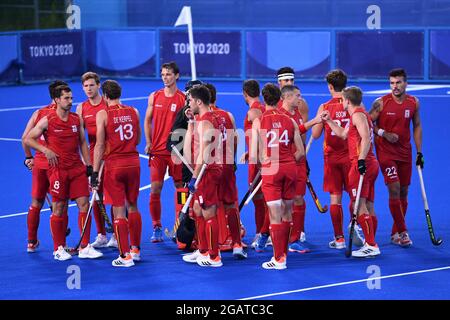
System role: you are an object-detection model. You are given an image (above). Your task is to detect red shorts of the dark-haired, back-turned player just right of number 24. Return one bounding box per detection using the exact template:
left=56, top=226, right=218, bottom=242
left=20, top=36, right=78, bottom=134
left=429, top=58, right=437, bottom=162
left=323, top=159, right=350, bottom=194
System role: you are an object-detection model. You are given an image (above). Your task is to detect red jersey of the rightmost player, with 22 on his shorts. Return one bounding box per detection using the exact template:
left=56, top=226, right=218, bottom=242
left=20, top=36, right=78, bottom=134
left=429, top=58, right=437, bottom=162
left=375, top=94, right=417, bottom=161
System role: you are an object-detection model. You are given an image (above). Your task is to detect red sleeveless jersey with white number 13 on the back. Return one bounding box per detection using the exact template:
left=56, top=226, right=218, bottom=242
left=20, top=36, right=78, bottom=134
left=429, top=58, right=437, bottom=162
left=104, top=105, right=140, bottom=168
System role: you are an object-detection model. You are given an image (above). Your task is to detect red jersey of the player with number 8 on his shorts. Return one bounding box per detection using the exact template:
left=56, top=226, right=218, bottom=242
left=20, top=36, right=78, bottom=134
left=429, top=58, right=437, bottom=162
left=44, top=112, right=83, bottom=169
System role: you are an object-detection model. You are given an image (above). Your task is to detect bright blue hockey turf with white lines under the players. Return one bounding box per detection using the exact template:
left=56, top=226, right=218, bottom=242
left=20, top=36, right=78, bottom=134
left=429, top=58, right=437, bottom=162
left=0, top=80, right=450, bottom=299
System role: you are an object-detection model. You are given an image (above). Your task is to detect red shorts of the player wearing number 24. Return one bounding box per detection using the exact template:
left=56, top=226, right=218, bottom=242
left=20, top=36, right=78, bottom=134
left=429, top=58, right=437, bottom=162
left=261, top=163, right=297, bottom=202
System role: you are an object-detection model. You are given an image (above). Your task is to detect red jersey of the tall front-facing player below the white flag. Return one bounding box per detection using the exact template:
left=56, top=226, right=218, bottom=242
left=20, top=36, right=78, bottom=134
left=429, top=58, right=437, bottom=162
left=150, top=89, right=185, bottom=156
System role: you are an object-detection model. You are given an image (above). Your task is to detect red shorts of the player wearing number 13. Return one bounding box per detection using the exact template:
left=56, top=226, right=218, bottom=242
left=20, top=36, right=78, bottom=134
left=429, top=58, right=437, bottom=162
left=103, top=166, right=141, bottom=207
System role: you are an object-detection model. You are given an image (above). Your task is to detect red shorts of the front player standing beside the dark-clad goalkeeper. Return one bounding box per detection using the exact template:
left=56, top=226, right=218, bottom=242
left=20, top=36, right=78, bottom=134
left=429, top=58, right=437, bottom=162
left=194, top=166, right=222, bottom=208
